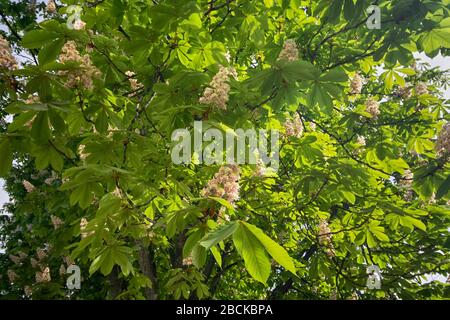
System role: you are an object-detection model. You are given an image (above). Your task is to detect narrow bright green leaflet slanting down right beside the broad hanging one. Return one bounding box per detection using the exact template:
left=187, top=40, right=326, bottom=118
left=241, top=222, right=296, bottom=274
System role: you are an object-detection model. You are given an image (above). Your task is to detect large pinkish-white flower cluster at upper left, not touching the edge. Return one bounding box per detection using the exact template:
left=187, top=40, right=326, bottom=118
left=59, top=41, right=101, bottom=90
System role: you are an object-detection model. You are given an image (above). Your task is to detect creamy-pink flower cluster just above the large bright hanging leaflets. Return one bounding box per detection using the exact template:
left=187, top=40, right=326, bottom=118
left=201, top=164, right=240, bottom=205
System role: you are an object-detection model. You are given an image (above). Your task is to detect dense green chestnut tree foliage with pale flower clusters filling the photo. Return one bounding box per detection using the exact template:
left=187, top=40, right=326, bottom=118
left=0, top=0, right=450, bottom=299
